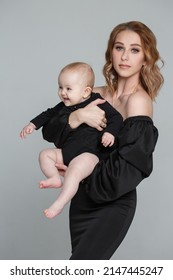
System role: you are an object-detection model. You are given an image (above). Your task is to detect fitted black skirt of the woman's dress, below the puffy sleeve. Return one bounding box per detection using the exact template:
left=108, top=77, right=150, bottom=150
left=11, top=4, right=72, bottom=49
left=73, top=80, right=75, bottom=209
left=70, top=184, right=136, bottom=260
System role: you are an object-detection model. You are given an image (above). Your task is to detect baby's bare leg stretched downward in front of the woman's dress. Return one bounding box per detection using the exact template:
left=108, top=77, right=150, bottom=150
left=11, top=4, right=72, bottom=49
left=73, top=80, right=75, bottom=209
left=44, top=153, right=99, bottom=218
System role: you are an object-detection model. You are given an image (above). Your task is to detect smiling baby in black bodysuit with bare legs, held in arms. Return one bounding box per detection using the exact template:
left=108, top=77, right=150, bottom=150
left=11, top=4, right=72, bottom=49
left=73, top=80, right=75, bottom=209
left=20, top=62, right=122, bottom=218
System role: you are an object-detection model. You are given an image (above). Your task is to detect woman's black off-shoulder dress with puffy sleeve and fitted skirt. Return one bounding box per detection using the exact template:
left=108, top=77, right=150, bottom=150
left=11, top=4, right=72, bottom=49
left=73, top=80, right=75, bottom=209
left=70, top=116, right=158, bottom=260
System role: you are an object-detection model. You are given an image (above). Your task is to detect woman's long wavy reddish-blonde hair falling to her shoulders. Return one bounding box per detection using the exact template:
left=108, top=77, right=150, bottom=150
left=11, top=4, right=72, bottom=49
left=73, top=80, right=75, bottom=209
left=103, top=21, right=164, bottom=100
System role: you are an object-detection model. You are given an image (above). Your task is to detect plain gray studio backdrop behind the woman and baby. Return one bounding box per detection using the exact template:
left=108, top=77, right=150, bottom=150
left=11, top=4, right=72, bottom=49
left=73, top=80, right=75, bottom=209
left=0, top=0, right=173, bottom=260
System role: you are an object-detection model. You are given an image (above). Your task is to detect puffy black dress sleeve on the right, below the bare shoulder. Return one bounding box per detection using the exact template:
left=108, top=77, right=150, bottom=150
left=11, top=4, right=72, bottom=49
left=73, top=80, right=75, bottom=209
left=85, top=116, right=158, bottom=203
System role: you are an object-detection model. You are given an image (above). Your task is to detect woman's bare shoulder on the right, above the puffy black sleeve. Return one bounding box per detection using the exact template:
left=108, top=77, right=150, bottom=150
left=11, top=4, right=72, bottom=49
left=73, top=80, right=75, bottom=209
left=126, top=90, right=153, bottom=118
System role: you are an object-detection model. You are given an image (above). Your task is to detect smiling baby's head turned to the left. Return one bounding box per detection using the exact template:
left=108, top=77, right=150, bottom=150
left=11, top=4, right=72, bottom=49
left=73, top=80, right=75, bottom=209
left=58, top=62, right=95, bottom=106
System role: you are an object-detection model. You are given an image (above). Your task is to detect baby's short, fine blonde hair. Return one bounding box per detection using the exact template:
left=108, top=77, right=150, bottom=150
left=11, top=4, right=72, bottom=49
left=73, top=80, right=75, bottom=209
left=59, top=62, right=95, bottom=89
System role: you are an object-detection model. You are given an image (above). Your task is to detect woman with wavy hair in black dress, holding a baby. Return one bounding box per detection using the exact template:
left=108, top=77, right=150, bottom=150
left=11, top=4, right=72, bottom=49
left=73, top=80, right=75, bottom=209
left=58, top=21, right=163, bottom=260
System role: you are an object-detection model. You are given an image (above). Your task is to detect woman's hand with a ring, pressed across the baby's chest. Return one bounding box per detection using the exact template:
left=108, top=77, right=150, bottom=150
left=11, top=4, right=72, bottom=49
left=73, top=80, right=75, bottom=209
left=69, top=98, right=106, bottom=131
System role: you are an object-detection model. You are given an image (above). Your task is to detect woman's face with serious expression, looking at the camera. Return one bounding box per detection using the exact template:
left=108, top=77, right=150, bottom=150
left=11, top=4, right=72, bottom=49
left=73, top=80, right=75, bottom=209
left=112, top=30, right=145, bottom=78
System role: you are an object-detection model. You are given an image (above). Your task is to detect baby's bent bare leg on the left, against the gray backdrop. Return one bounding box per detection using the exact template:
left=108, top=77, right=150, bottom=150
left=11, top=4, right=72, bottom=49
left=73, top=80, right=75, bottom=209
left=39, top=149, right=63, bottom=189
